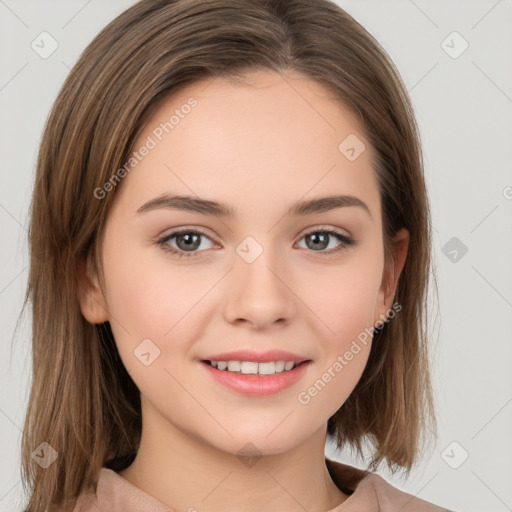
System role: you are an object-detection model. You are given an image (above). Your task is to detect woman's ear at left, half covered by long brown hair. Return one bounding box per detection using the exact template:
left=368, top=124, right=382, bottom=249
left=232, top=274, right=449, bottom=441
left=78, top=255, right=109, bottom=324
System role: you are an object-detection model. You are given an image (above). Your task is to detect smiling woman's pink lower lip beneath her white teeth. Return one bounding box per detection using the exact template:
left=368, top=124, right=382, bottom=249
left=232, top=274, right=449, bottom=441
left=201, top=361, right=311, bottom=396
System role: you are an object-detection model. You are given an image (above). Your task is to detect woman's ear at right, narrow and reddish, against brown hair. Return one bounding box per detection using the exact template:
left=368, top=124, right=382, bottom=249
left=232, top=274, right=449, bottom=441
left=374, top=228, right=410, bottom=325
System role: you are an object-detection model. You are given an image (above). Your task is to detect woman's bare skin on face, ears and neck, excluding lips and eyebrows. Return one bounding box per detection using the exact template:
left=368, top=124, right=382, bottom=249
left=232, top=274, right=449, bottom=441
left=81, top=71, right=409, bottom=512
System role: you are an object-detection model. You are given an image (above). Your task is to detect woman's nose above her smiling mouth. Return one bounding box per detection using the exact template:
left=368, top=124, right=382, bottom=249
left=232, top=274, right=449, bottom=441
left=224, top=246, right=296, bottom=330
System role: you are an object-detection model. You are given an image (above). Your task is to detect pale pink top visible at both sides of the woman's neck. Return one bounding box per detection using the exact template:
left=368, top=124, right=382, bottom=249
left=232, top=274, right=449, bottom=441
left=73, top=457, right=450, bottom=512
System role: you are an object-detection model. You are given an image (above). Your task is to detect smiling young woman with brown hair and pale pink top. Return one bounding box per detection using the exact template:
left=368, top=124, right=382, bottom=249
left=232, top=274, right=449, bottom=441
left=22, top=0, right=452, bottom=512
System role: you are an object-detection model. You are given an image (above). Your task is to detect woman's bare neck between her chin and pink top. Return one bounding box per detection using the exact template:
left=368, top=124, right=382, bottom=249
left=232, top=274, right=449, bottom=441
left=119, top=402, right=348, bottom=512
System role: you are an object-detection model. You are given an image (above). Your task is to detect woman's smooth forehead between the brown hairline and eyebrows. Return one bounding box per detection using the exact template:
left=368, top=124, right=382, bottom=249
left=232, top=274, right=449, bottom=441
left=112, top=67, right=379, bottom=222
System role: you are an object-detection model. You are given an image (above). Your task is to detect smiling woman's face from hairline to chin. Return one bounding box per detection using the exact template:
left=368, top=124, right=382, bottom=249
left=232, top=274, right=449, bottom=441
left=82, top=68, right=403, bottom=454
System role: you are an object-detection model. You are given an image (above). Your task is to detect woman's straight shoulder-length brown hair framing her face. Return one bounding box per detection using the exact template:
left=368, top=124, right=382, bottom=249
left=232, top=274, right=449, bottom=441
left=22, top=0, right=436, bottom=512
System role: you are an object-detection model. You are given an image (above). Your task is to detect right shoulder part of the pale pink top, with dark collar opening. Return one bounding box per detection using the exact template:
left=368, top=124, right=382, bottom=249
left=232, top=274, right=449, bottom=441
left=326, top=458, right=451, bottom=512
